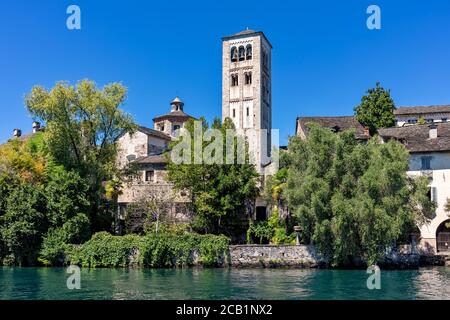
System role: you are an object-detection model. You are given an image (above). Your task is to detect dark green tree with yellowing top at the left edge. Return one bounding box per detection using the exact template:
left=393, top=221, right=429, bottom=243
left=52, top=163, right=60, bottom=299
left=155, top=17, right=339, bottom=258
left=0, top=133, right=90, bottom=265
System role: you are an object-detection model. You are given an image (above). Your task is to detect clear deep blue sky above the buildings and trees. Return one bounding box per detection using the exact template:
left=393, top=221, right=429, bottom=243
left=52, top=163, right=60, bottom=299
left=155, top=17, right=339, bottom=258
left=0, top=0, right=450, bottom=144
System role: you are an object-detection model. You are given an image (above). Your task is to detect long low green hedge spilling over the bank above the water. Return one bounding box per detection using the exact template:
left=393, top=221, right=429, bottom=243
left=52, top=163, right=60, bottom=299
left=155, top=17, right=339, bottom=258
left=66, top=231, right=229, bottom=268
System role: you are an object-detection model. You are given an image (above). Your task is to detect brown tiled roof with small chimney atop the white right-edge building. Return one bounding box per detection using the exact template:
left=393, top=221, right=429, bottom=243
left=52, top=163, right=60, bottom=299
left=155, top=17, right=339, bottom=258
left=378, top=123, right=450, bottom=152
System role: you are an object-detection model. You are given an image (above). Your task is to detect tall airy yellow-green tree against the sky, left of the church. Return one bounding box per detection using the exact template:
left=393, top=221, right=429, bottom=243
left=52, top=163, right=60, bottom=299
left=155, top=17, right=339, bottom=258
left=25, top=80, right=135, bottom=229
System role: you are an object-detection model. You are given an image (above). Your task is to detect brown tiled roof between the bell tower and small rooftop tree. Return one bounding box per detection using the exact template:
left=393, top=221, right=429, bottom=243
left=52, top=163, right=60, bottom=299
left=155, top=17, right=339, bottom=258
left=296, top=116, right=370, bottom=140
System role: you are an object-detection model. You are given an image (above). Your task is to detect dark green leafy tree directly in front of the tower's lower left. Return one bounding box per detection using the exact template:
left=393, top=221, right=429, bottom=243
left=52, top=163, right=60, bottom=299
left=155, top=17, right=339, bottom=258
left=168, top=118, right=259, bottom=238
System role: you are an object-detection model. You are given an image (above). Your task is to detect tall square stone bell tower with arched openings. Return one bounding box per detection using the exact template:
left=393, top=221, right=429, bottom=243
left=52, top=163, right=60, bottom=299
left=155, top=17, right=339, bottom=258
left=222, top=30, right=272, bottom=173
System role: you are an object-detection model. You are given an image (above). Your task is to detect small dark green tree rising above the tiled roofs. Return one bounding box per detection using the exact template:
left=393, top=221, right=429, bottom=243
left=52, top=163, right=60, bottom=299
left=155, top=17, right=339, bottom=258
left=354, top=82, right=395, bottom=135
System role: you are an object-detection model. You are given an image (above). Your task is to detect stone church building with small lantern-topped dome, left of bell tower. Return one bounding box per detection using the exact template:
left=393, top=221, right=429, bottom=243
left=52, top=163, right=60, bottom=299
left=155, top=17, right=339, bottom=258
left=117, top=97, right=193, bottom=232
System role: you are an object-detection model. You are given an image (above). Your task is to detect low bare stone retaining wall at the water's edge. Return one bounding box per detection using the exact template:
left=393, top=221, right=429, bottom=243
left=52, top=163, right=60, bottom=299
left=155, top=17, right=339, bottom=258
left=229, top=245, right=326, bottom=268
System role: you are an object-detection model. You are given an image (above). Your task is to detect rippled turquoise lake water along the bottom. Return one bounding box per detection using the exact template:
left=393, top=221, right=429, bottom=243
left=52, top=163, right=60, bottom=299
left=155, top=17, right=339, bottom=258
left=0, top=267, right=450, bottom=300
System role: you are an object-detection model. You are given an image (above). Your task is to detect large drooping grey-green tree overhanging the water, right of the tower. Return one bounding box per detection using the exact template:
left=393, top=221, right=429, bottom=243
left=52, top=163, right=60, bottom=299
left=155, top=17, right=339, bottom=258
left=285, top=126, right=434, bottom=265
